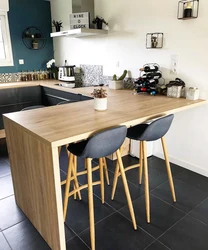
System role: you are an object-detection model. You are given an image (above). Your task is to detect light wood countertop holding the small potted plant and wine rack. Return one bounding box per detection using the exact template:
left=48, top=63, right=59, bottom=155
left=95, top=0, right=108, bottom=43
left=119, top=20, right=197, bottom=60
left=4, top=81, right=207, bottom=147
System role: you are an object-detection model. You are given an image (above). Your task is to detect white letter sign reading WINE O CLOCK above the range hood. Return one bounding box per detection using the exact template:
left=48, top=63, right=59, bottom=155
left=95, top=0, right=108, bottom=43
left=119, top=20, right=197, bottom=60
left=70, top=12, right=90, bottom=29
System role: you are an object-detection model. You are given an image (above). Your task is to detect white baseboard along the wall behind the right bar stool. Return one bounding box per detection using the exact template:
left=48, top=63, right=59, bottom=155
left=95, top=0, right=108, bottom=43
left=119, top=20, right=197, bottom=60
left=154, top=153, right=208, bottom=177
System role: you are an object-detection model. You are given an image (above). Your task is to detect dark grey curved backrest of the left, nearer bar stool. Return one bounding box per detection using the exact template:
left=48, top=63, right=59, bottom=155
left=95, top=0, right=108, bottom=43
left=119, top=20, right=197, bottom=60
left=82, top=126, right=127, bottom=158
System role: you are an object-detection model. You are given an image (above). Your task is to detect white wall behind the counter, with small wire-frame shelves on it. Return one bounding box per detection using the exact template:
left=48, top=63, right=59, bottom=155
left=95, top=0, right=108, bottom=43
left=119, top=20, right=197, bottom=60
left=52, top=0, right=208, bottom=176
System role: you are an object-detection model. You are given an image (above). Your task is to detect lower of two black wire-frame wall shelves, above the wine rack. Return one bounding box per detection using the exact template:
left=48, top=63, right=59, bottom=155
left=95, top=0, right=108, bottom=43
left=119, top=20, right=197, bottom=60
left=146, top=32, right=163, bottom=49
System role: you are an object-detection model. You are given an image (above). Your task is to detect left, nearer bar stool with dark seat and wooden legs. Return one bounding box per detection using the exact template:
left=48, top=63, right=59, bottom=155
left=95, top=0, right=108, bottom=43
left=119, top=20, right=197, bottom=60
left=64, top=126, right=137, bottom=250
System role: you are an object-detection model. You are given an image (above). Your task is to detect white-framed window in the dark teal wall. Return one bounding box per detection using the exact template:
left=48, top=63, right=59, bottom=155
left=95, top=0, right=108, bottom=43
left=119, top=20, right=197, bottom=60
left=0, top=11, right=14, bottom=67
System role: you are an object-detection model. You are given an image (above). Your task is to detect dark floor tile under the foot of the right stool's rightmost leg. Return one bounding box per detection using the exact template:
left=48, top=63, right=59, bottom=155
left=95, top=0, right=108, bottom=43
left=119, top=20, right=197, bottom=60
left=152, top=179, right=207, bottom=213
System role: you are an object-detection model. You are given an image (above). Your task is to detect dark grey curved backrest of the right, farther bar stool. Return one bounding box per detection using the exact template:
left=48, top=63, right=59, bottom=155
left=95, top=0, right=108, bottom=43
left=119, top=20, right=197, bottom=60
left=139, top=115, right=174, bottom=141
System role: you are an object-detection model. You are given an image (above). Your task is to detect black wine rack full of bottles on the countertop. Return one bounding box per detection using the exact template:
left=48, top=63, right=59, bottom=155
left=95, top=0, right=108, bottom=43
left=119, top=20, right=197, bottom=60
left=135, top=63, right=162, bottom=95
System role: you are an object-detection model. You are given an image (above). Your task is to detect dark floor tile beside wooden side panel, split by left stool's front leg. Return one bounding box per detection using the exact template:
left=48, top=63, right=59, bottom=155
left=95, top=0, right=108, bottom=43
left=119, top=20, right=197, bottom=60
left=65, top=190, right=114, bottom=234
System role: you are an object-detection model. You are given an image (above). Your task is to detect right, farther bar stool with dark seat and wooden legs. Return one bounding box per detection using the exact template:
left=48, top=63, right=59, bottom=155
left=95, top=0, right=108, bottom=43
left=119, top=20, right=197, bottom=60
left=111, top=115, right=176, bottom=223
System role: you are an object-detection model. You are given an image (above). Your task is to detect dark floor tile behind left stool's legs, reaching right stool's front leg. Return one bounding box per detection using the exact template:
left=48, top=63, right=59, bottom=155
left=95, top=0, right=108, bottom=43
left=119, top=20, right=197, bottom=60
left=79, top=170, right=144, bottom=209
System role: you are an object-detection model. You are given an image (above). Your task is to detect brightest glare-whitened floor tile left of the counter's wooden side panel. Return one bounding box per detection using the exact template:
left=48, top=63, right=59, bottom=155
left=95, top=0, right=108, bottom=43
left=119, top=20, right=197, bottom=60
left=0, top=196, right=26, bottom=230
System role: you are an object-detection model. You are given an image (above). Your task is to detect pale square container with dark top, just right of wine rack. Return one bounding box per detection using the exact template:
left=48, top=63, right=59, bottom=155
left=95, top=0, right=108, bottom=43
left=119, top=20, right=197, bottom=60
left=166, top=78, right=185, bottom=98
